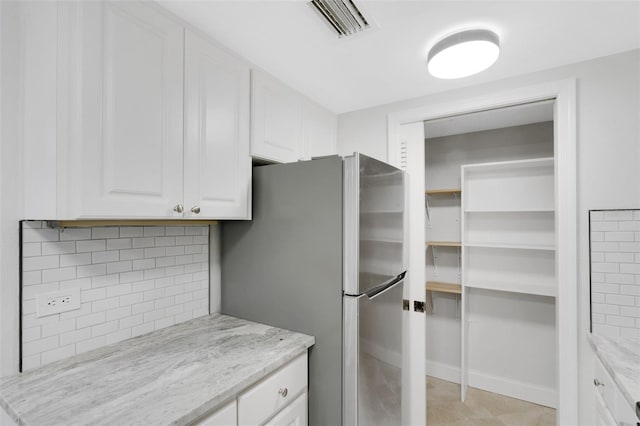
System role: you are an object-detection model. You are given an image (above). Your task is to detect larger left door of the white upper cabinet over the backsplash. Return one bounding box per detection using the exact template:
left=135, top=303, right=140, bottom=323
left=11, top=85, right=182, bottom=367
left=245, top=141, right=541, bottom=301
left=62, top=1, right=184, bottom=218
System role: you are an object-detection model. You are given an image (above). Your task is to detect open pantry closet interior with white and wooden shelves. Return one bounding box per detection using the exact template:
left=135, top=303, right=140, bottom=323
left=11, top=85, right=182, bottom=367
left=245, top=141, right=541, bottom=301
left=424, top=100, right=557, bottom=408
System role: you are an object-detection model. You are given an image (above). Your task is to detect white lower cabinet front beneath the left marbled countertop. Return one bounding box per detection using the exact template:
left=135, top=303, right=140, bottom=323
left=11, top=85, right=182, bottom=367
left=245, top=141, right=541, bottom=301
left=195, top=353, right=308, bottom=426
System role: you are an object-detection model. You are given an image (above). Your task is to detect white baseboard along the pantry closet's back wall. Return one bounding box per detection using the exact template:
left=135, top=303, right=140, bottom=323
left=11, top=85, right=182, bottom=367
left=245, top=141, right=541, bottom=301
left=425, top=360, right=558, bottom=408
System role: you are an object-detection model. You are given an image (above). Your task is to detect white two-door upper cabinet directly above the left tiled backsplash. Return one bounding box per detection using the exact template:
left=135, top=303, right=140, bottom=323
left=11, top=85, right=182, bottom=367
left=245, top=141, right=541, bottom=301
left=58, top=1, right=251, bottom=219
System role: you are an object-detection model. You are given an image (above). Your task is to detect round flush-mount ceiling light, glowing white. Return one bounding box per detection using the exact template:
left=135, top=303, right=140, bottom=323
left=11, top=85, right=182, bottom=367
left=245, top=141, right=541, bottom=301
left=427, top=30, right=500, bottom=79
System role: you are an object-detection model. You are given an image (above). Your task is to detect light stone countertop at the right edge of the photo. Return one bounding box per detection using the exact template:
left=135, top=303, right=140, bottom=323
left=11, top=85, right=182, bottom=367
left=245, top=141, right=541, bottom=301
left=588, top=333, right=640, bottom=417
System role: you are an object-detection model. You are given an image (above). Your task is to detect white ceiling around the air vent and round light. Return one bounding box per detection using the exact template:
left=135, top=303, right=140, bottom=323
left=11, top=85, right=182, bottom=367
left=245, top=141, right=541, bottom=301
left=159, top=0, right=640, bottom=113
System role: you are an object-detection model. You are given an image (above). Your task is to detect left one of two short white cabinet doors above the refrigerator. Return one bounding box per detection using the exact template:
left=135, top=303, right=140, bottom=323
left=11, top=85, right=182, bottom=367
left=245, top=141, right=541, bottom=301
left=251, top=71, right=304, bottom=163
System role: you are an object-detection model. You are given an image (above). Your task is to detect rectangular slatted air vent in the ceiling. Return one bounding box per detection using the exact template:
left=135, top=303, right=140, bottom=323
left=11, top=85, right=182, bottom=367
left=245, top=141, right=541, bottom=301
left=309, top=0, right=370, bottom=37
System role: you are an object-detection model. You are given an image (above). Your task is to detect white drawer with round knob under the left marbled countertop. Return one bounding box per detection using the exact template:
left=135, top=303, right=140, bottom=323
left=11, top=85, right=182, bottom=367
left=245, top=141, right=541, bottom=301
left=238, top=353, right=307, bottom=425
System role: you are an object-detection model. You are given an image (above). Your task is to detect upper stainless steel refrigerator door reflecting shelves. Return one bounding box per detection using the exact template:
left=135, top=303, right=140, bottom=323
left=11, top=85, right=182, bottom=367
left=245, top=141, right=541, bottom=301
left=344, top=153, right=406, bottom=295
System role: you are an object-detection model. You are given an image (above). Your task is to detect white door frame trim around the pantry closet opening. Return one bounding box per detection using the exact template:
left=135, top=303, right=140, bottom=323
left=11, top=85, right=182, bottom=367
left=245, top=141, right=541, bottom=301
left=387, top=78, right=579, bottom=424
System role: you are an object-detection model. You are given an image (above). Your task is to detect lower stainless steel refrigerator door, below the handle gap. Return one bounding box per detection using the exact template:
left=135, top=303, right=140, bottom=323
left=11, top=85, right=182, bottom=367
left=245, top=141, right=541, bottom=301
left=343, top=281, right=403, bottom=426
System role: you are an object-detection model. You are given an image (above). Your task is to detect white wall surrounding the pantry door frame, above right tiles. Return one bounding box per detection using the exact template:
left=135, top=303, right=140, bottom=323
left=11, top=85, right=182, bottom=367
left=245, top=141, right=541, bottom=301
left=338, top=50, right=640, bottom=424
